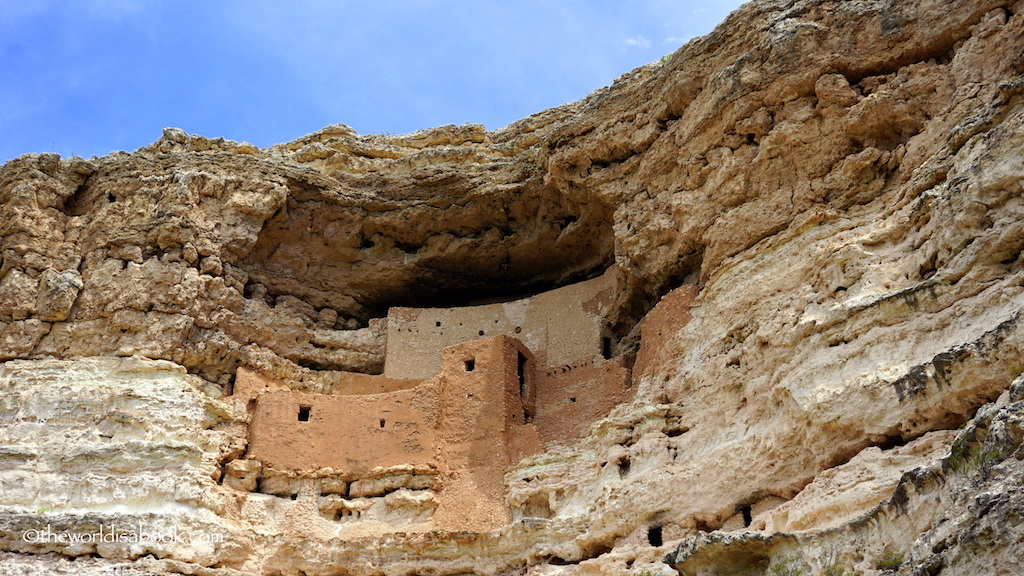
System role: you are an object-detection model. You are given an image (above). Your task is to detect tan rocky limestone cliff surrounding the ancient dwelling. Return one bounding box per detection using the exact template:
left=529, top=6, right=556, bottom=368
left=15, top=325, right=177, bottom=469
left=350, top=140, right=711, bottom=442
left=0, top=0, right=1024, bottom=575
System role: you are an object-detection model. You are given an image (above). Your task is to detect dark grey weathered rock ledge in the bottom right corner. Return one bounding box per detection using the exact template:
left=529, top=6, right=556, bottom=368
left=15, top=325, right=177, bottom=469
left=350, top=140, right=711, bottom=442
left=666, top=378, right=1024, bottom=576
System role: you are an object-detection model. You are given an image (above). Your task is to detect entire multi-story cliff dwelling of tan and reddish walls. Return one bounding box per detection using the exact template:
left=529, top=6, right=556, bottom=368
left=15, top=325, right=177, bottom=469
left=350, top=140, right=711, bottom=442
left=224, top=272, right=632, bottom=531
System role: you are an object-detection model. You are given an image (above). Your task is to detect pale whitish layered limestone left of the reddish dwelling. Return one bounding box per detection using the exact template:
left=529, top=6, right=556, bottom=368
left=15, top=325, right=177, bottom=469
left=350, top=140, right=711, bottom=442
left=0, top=358, right=247, bottom=573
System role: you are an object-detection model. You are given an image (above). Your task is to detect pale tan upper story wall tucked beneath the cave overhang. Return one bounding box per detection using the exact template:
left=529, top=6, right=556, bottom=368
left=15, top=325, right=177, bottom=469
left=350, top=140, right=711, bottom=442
left=384, top=270, right=615, bottom=378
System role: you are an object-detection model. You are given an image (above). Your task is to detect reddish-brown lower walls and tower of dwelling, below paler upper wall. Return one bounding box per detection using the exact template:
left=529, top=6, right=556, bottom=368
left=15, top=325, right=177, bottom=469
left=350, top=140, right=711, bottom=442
left=234, top=327, right=632, bottom=530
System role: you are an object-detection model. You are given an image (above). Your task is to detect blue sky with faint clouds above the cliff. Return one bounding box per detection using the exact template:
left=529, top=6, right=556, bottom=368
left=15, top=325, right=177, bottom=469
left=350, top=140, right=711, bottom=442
left=0, top=0, right=741, bottom=162
